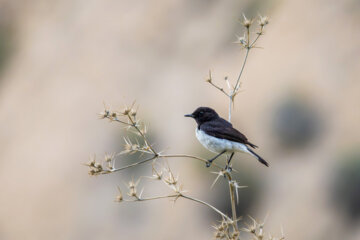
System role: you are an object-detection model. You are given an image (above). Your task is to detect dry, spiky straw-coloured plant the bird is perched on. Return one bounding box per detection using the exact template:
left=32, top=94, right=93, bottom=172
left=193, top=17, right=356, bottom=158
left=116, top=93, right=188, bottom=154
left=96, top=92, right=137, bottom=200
left=86, top=15, right=284, bottom=240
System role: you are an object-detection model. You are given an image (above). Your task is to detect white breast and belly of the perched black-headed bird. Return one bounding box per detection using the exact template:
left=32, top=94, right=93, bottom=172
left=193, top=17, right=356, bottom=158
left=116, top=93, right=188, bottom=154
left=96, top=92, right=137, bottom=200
left=195, top=128, right=249, bottom=153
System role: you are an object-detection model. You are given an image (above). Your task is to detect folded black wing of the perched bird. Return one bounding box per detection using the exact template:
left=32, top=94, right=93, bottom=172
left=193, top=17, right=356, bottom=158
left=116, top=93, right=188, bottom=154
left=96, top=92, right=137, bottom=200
left=200, top=118, right=257, bottom=148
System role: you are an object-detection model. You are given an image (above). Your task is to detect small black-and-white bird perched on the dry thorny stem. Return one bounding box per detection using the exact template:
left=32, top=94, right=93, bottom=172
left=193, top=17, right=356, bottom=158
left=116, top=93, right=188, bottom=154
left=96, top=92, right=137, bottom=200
left=185, top=107, right=269, bottom=171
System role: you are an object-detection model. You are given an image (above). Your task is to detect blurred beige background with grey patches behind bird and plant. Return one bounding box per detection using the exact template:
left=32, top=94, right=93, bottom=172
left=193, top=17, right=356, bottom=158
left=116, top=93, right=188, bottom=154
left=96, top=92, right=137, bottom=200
left=0, top=0, right=360, bottom=240
